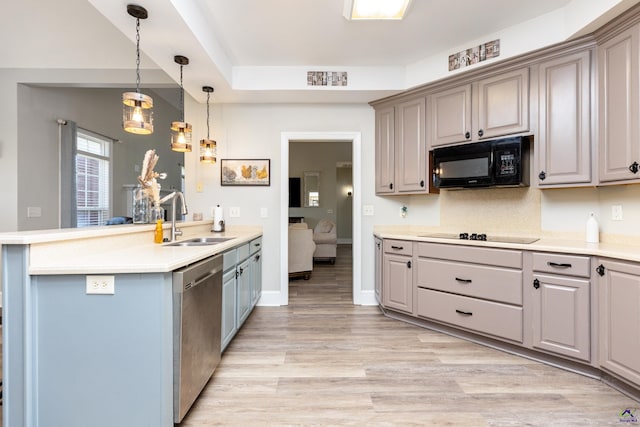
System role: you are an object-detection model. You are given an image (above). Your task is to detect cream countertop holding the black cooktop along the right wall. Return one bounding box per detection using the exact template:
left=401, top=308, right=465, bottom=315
left=374, top=226, right=640, bottom=262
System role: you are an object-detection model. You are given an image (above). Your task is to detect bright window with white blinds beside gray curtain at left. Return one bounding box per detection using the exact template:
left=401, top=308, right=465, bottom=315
left=75, top=129, right=111, bottom=227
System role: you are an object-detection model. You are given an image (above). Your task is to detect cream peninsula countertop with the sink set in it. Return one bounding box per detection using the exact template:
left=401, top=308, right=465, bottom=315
left=0, top=221, right=262, bottom=275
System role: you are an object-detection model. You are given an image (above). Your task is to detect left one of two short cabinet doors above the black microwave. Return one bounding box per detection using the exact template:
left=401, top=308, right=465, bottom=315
left=427, top=84, right=471, bottom=148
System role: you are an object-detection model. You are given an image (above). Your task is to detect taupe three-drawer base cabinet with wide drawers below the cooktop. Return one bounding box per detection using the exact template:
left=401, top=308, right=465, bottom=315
left=415, top=243, right=523, bottom=343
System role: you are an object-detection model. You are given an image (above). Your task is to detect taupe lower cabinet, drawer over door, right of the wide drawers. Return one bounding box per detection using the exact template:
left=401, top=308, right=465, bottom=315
left=527, top=252, right=591, bottom=362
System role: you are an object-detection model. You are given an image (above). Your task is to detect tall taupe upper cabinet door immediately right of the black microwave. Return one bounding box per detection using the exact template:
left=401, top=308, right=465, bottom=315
left=536, top=51, right=591, bottom=186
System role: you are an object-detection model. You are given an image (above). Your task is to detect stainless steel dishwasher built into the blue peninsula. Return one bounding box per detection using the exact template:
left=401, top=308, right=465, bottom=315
left=173, top=255, right=222, bottom=423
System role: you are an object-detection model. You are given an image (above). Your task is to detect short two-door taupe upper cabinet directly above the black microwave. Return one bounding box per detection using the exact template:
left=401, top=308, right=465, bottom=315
left=429, top=67, right=529, bottom=148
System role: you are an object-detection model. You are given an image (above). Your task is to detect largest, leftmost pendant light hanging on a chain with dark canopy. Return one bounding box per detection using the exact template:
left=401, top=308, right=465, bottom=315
left=122, top=4, right=153, bottom=135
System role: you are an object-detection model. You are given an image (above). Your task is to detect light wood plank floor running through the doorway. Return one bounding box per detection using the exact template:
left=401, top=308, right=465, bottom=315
left=181, top=246, right=640, bottom=427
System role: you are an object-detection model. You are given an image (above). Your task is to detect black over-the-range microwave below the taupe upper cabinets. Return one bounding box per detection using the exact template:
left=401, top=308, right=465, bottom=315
left=433, top=136, right=530, bottom=188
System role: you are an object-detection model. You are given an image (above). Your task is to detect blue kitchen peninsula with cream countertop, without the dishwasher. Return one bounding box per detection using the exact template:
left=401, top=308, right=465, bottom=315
left=0, top=221, right=262, bottom=426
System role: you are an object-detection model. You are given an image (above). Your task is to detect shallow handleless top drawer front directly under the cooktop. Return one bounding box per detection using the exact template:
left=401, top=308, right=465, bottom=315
left=417, top=243, right=522, bottom=268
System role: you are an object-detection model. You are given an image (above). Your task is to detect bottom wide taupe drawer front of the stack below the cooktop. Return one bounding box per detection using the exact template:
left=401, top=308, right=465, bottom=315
left=416, top=289, right=522, bottom=343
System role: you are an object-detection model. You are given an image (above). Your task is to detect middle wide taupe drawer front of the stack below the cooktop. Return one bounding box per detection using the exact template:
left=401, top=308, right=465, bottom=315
left=417, top=258, right=522, bottom=305
